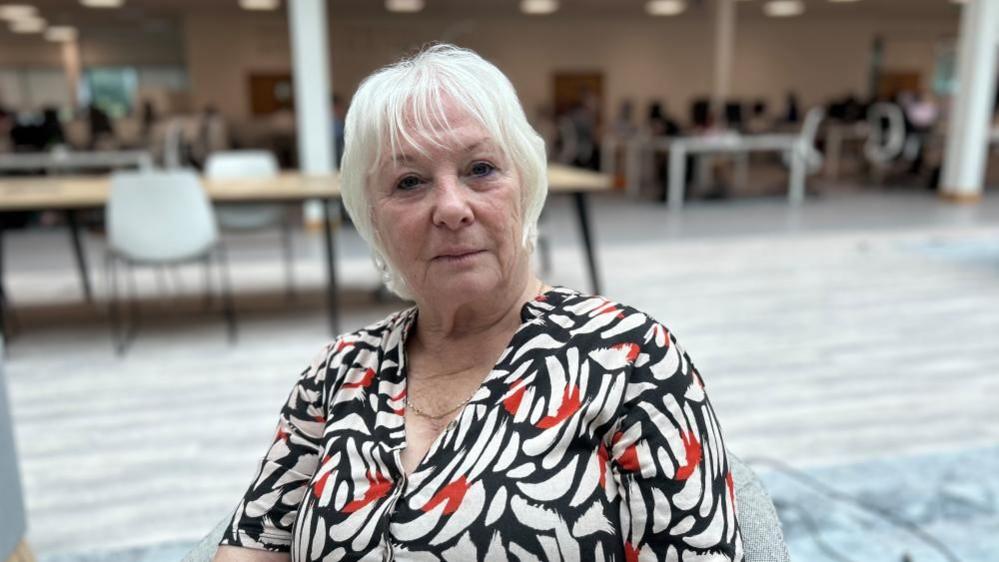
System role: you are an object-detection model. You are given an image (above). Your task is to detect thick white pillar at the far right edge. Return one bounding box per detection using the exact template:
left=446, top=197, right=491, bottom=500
left=940, top=0, right=999, bottom=201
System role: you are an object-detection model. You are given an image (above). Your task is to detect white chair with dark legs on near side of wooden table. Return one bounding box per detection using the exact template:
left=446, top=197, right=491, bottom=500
left=105, top=170, right=236, bottom=353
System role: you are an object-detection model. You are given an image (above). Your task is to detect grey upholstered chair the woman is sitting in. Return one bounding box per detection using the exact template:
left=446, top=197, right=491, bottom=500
left=183, top=453, right=791, bottom=562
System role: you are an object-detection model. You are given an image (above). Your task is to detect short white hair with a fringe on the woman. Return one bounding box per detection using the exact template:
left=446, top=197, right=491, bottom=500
left=340, top=44, right=548, bottom=298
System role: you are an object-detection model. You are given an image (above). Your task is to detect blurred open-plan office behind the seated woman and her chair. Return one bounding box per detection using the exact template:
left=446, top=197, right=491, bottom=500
left=0, top=0, right=999, bottom=562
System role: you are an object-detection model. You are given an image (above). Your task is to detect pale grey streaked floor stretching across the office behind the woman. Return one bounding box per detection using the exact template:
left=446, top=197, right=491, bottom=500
left=4, top=179, right=999, bottom=562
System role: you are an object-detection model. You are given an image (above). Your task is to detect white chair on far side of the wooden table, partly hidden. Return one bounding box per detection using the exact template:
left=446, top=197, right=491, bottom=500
left=205, top=150, right=295, bottom=297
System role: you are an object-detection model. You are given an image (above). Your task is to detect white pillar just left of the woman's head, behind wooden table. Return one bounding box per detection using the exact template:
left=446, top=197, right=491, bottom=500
left=288, top=0, right=333, bottom=223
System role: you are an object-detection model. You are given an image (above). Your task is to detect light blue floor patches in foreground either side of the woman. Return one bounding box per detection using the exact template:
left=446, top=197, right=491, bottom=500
left=39, top=446, right=999, bottom=562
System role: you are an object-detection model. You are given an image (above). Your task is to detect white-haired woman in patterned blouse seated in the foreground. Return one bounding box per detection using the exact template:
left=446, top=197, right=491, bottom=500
left=216, top=45, right=742, bottom=561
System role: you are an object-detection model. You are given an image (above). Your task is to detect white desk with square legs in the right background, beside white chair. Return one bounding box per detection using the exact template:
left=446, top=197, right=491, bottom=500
left=667, top=134, right=808, bottom=210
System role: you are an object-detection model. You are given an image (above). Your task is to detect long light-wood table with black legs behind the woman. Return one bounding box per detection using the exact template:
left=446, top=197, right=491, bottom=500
left=0, top=164, right=611, bottom=334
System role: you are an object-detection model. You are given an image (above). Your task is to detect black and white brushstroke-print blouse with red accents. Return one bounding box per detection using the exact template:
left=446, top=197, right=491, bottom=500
left=222, top=288, right=743, bottom=562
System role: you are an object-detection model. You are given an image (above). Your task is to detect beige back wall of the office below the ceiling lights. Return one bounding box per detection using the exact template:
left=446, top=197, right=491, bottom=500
left=0, top=11, right=958, bottom=119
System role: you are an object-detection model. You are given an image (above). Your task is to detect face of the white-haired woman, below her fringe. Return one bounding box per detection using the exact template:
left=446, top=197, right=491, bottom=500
left=368, top=105, right=529, bottom=302
